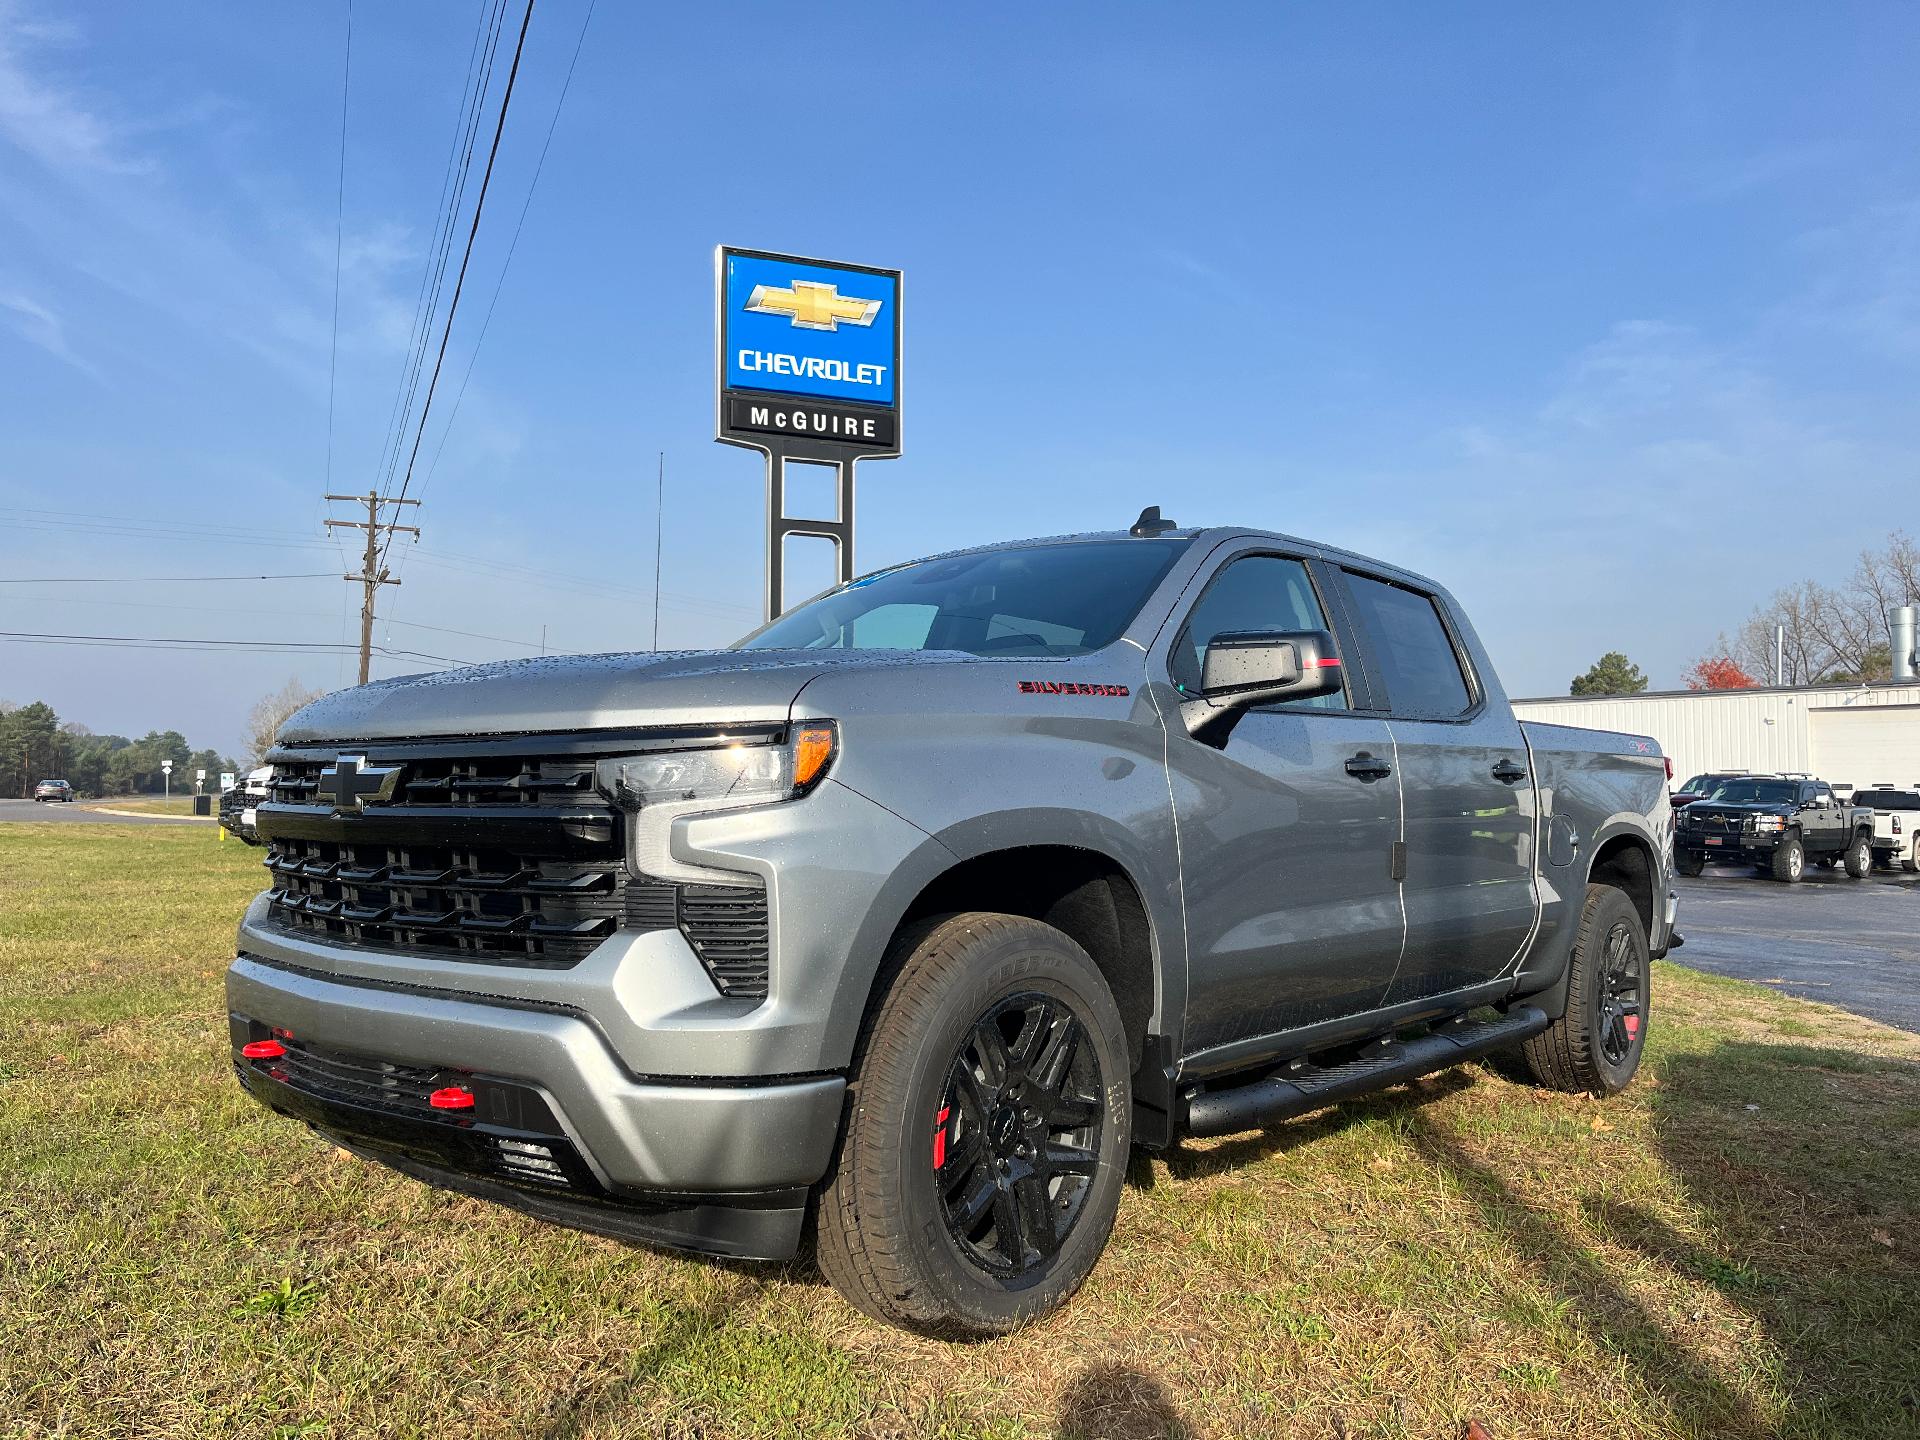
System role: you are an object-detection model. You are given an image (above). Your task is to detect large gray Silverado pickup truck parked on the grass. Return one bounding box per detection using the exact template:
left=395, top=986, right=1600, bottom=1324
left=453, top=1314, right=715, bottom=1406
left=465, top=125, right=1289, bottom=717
left=227, top=511, right=1676, bottom=1334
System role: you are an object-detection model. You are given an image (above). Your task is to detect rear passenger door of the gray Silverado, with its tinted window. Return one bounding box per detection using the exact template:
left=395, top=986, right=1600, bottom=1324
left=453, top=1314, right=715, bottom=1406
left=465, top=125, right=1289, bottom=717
left=1340, top=568, right=1538, bottom=1004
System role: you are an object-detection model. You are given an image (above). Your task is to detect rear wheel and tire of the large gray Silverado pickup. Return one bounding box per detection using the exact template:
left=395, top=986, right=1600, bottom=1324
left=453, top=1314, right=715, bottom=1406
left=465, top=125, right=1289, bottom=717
left=1521, top=885, right=1653, bottom=1096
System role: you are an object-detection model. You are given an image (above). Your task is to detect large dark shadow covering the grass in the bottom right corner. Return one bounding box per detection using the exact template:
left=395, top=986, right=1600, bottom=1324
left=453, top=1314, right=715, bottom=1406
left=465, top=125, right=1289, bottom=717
left=1628, top=1041, right=1920, bottom=1436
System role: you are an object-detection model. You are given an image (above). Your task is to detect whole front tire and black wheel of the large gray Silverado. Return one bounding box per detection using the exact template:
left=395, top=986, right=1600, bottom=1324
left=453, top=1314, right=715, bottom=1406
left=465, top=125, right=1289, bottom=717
left=816, top=912, right=1133, bottom=1338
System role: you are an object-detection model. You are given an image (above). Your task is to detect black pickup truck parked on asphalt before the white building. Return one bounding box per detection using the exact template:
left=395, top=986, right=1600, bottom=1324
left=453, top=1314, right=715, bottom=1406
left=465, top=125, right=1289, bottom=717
left=1674, top=776, right=1874, bottom=885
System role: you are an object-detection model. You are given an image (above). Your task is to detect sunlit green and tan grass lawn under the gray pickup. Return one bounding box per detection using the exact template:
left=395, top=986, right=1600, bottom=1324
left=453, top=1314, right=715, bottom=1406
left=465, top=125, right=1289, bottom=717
left=0, top=824, right=1920, bottom=1440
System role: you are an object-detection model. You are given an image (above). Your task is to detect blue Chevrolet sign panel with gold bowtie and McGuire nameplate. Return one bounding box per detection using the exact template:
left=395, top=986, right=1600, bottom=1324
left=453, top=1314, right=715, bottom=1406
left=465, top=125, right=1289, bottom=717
left=718, top=248, right=900, bottom=453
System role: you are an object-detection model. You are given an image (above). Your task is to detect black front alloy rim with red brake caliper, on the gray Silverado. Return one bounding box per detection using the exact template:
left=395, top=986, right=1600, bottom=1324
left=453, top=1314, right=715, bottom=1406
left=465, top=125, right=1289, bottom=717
left=933, top=993, right=1104, bottom=1281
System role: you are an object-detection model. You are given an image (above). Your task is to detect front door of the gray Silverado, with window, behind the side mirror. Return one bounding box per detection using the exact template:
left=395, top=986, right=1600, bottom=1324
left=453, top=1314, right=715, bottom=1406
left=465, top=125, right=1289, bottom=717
left=1169, top=553, right=1402, bottom=1054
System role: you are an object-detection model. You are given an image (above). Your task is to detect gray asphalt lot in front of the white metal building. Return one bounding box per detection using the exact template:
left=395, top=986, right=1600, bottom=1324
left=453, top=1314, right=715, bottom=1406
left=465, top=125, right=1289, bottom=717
left=1668, top=866, right=1920, bottom=1031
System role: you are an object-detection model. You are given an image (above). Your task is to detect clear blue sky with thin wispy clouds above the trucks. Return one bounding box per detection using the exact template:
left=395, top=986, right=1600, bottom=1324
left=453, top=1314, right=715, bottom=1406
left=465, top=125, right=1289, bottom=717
left=0, top=0, right=1920, bottom=745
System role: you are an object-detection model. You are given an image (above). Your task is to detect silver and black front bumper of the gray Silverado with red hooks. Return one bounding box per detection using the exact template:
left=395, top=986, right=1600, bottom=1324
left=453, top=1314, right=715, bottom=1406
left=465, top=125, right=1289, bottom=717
left=227, top=954, right=845, bottom=1260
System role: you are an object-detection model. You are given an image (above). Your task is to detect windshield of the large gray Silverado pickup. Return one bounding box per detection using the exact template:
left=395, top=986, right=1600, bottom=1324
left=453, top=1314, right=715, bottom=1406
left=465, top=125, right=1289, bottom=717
left=733, top=540, right=1190, bottom=655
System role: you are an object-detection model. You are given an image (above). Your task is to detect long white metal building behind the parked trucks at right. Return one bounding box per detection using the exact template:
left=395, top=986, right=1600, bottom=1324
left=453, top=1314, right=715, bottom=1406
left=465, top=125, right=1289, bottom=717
left=1513, top=684, right=1920, bottom=789
